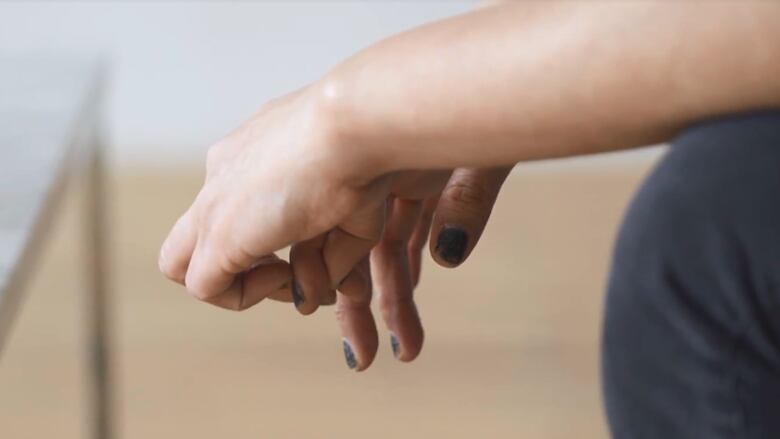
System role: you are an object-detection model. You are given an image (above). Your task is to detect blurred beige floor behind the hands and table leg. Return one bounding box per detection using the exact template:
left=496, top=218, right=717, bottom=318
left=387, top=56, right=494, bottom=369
left=0, top=159, right=646, bottom=439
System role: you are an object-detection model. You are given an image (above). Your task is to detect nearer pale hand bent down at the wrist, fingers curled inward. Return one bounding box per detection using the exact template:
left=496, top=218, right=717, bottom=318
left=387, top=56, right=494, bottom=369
left=160, top=87, right=393, bottom=311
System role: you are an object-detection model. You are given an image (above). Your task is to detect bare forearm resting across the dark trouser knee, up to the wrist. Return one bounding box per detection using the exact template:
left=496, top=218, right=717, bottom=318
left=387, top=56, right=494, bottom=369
left=322, top=2, right=780, bottom=171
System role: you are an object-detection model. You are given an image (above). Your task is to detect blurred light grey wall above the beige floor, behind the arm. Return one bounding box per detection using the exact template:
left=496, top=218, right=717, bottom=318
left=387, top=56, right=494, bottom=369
left=0, top=1, right=475, bottom=164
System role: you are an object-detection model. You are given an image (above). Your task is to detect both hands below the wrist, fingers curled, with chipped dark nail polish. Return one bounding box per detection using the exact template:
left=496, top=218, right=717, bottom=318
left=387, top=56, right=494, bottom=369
left=160, top=85, right=509, bottom=370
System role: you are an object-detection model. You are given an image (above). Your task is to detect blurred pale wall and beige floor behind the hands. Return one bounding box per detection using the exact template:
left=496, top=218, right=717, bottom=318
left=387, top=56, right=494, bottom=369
left=0, top=1, right=662, bottom=439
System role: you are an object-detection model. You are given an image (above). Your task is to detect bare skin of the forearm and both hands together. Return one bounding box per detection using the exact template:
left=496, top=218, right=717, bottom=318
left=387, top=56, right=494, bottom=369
left=160, top=2, right=780, bottom=370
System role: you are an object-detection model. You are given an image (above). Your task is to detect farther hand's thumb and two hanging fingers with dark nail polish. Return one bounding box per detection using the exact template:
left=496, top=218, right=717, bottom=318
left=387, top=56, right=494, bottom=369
left=360, top=168, right=511, bottom=370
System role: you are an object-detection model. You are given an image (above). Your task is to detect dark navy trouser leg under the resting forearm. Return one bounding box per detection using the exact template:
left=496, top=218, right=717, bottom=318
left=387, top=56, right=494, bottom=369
left=602, top=111, right=780, bottom=439
